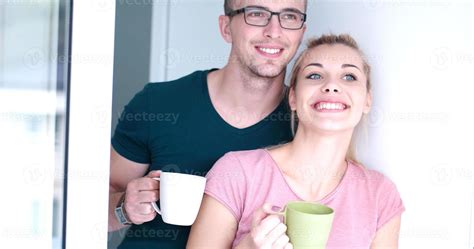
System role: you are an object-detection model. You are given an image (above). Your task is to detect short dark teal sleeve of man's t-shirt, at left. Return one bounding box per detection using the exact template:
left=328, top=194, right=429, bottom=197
left=112, top=85, right=150, bottom=163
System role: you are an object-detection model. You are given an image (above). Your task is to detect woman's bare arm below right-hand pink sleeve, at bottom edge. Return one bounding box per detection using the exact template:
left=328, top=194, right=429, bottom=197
left=370, top=215, right=401, bottom=249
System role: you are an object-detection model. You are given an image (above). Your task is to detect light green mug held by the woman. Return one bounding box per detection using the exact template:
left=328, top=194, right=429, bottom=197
left=276, top=201, right=334, bottom=249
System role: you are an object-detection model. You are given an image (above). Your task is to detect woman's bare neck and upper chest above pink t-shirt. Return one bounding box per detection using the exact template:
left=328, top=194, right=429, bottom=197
left=272, top=128, right=352, bottom=200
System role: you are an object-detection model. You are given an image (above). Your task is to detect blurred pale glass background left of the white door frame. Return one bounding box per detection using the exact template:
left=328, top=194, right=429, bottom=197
left=0, top=0, right=70, bottom=248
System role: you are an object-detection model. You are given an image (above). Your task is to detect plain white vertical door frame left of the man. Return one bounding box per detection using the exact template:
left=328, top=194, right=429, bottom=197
left=65, top=0, right=116, bottom=249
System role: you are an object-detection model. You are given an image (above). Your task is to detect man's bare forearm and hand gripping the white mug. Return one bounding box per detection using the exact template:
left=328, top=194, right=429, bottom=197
left=109, top=147, right=158, bottom=232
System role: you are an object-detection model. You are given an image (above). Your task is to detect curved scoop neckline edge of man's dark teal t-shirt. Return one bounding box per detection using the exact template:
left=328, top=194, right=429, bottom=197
left=201, top=68, right=285, bottom=134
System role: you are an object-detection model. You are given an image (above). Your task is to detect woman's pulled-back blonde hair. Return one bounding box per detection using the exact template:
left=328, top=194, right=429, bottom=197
left=287, top=34, right=372, bottom=162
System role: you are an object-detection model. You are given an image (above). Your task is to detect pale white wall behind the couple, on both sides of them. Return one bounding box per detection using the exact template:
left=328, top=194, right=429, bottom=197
left=150, top=0, right=474, bottom=248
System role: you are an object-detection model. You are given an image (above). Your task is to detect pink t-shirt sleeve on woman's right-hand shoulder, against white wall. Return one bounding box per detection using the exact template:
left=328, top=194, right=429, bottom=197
left=377, top=178, right=405, bottom=230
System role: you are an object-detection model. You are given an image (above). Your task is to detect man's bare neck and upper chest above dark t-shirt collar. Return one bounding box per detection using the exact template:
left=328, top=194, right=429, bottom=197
left=208, top=65, right=285, bottom=128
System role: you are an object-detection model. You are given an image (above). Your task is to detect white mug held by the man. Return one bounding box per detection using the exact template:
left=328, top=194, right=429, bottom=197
left=151, top=172, right=206, bottom=226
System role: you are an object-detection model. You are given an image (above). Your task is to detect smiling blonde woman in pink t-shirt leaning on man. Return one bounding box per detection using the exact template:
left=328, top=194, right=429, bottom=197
left=188, top=35, right=404, bottom=249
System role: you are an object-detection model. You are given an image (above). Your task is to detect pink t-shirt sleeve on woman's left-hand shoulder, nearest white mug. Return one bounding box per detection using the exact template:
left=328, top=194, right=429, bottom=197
left=205, top=153, right=247, bottom=220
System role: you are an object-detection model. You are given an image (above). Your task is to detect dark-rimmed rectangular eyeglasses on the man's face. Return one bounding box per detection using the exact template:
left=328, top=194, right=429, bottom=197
left=226, top=7, right=306, bottom=30
